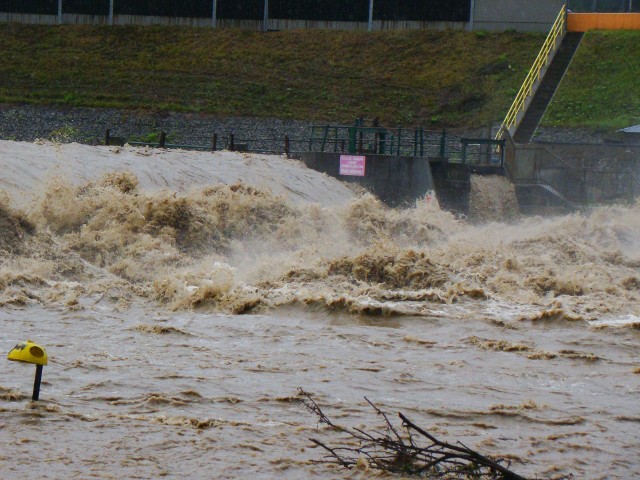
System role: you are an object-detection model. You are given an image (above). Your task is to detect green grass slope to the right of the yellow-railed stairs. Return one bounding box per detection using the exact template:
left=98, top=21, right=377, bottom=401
left=543, top=31, right=640, bottom=131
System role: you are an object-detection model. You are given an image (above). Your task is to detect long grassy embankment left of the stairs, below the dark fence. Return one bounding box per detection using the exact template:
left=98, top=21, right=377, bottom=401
left=0, top=25, right=544, bottom=127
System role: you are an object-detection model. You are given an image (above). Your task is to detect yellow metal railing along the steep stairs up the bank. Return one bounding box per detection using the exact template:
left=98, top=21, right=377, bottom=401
left=495, top=5, right=567, bottom=140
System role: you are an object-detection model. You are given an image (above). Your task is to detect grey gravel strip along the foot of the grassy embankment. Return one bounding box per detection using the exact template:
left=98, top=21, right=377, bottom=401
left=0, top=105, right=603, bottom=152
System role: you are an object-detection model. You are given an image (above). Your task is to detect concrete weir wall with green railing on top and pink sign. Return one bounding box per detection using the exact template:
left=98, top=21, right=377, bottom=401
left=295, top=118, right=505, bottom=215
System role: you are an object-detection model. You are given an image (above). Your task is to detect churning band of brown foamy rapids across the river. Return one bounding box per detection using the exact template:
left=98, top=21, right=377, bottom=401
left=0, top=172, right=640, bottom=322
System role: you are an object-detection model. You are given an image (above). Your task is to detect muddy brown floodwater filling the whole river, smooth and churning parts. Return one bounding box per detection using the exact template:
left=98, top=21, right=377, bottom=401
left=0, top=142, right=640, bottom=479
